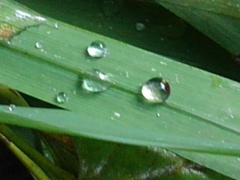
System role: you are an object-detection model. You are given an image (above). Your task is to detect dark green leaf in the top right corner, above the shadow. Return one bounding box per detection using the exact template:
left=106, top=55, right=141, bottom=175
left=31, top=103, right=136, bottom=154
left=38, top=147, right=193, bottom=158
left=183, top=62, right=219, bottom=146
left=157, top=0, right=240, bottom=55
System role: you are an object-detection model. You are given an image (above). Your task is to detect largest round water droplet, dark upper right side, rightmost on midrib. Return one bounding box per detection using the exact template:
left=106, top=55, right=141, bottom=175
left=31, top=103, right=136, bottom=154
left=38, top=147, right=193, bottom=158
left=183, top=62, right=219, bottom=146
left=141, top=78, right=170, bottom=103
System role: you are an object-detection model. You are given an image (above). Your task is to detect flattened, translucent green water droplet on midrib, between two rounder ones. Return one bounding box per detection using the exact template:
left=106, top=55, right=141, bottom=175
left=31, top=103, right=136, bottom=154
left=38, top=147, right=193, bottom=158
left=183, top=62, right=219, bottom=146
left=82, top=69, right=111, bottom=93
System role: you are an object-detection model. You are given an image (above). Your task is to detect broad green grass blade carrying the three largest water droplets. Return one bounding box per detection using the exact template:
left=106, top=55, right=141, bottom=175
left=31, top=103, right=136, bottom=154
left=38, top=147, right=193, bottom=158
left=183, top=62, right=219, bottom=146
left=0, top=0, right=240, bottom=177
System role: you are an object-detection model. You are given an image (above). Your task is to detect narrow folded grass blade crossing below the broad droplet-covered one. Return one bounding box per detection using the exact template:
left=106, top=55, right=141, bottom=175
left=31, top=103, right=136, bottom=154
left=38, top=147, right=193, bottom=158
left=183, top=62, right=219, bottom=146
left=0, top=106, right=240, bottom=177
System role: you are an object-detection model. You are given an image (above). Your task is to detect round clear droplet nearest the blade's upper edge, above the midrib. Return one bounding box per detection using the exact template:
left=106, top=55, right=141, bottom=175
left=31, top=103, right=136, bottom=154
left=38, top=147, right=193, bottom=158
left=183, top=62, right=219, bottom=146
left=87, top=41, right=107, bottom=58
